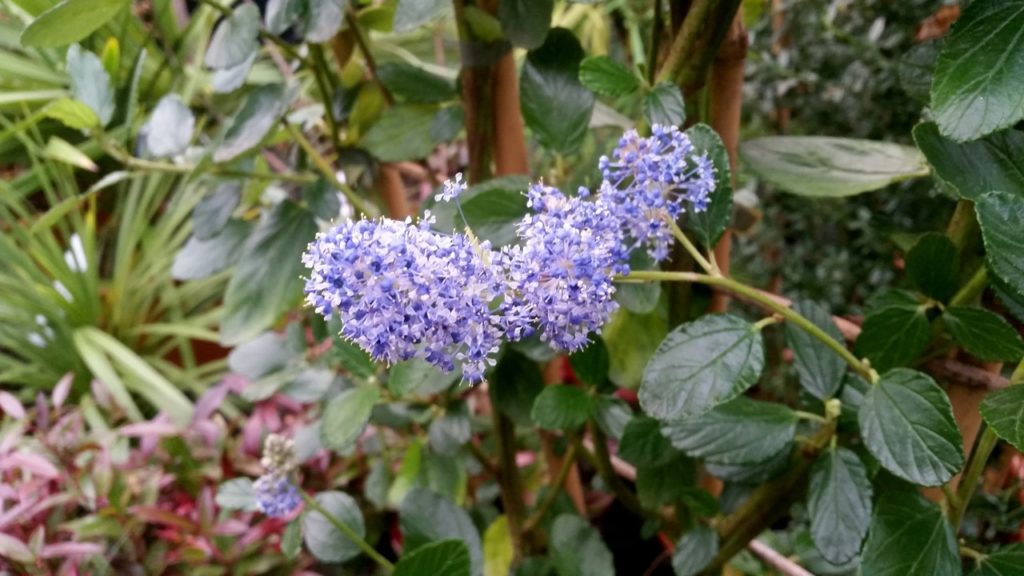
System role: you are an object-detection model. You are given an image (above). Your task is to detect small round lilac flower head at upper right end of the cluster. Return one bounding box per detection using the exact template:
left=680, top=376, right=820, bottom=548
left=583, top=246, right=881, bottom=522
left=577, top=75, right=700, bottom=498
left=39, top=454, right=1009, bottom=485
left=598, top=124, right=715, bottom=260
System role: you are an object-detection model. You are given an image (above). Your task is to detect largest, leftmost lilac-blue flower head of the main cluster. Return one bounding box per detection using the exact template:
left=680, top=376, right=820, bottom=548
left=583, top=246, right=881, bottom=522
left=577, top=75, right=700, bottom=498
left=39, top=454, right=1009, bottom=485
left=302, top=214, right=505, bottom=383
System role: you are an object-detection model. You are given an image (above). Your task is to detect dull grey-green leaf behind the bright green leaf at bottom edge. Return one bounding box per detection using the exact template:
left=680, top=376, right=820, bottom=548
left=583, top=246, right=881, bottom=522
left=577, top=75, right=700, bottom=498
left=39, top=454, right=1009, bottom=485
left=398, top=488, right=483, bottom=574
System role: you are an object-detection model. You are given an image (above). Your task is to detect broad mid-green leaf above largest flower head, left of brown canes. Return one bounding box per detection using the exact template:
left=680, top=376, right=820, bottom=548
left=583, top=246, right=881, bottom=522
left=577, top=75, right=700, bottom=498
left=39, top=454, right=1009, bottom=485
left=362, top=106, right=434, bottom=162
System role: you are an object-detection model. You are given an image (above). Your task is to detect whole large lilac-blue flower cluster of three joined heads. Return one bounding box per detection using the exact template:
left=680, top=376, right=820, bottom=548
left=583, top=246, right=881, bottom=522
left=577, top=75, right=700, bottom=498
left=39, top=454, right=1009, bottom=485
left=303, top=125, right=715, bottom=383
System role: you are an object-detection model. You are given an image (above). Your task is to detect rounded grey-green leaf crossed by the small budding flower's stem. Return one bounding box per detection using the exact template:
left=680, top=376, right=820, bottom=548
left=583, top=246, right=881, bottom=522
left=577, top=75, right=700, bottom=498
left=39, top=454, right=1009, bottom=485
left=302, top=491, right=367, bottom=563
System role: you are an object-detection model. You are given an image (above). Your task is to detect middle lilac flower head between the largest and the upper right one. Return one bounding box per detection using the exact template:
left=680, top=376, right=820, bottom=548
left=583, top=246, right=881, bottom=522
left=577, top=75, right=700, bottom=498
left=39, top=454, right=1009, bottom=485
left=503, top=183, right=629, bottom=351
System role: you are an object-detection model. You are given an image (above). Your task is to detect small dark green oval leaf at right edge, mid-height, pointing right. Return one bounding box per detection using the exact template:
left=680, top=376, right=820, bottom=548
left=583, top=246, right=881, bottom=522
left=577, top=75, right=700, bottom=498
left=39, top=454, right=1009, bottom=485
left=942, top=306, right=1024, bottom=362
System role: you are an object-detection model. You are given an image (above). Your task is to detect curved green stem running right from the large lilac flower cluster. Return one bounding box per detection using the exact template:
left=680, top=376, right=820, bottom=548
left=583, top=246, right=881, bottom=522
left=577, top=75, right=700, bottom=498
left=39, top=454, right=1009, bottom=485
left=623, top=271, right=879, bottom=383
